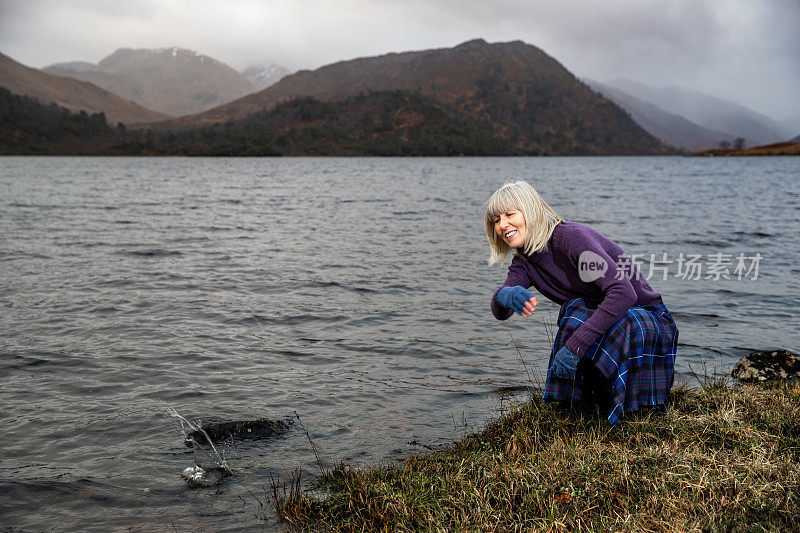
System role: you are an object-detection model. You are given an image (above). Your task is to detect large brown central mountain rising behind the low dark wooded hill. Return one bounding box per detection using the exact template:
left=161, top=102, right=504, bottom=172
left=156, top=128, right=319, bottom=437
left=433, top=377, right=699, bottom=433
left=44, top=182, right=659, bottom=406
left=166, top=40, right=670, bottom=155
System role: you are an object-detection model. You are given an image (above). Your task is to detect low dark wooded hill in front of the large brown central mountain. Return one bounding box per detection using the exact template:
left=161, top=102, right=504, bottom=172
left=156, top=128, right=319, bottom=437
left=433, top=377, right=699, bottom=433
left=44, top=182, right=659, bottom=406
left=122, top=91, right=521, bottom=156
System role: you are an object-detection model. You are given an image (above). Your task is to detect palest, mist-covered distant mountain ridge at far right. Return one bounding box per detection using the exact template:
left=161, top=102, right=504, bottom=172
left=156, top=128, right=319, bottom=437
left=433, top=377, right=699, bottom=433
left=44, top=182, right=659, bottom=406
left=606, top=79, right=789, bottom=145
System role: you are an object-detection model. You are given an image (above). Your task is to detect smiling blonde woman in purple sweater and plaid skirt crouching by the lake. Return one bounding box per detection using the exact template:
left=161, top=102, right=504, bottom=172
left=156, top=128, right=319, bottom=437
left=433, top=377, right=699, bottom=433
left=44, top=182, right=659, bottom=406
left=486, top=180, right=678, bottom=424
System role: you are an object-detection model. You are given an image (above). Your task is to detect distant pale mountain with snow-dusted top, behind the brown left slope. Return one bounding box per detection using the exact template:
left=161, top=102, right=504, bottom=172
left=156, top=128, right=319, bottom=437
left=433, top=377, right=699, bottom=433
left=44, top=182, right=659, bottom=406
left=43, top=47, right=258, bottom=116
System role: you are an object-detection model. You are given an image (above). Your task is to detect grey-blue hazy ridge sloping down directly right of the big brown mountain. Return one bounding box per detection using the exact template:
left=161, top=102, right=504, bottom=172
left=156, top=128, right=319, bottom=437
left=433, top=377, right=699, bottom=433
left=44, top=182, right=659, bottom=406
left=583, top=79, right=735, bottom=152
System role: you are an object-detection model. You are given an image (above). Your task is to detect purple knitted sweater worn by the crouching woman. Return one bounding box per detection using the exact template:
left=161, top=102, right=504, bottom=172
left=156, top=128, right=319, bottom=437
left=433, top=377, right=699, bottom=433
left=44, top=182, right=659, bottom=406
left=492, top=221, right=661, bottom=356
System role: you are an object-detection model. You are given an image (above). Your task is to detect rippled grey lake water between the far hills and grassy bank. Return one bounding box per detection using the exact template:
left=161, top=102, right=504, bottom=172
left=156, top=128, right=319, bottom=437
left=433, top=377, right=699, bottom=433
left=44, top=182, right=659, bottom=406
left=0, top=157, right=800, bottom=531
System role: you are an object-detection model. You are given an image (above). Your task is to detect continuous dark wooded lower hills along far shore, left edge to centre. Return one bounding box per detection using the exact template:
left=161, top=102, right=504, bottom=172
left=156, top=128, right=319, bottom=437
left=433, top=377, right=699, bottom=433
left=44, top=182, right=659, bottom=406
left=0, top=88, right=519, bottom=156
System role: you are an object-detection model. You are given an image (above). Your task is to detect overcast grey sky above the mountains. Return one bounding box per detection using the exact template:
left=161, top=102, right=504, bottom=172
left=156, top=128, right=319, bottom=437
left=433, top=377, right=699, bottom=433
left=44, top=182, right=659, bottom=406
left=0, top=0, right=800, bottom=120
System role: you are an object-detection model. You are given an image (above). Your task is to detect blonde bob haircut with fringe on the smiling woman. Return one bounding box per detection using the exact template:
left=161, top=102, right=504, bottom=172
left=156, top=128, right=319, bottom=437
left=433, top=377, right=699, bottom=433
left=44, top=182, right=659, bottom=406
left=486, top=180, right=564, bottom=265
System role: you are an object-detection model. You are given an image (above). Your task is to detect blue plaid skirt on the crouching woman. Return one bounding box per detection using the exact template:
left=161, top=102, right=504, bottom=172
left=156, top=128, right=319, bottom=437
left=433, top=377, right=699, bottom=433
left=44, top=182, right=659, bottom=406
left=544, top=298, right=678, bottom=424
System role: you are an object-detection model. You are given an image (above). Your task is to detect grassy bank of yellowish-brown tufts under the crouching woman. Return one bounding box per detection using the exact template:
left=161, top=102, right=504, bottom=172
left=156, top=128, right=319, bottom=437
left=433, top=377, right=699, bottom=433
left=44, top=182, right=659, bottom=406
left=276, top=384, right=800, bottom=531
